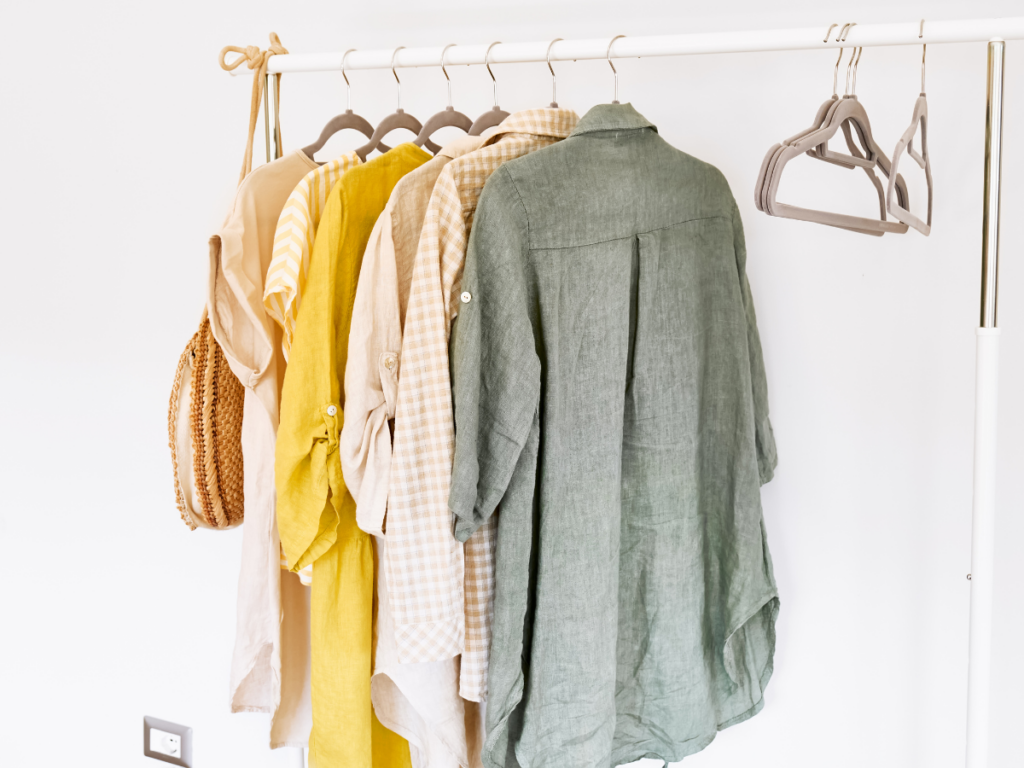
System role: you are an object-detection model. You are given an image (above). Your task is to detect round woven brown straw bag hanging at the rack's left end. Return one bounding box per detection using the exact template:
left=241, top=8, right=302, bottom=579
left=167, top=313, right=245, bottom=530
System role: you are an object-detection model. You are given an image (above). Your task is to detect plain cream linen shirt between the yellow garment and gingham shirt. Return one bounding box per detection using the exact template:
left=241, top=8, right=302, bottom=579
left=339, top=136, right=483, bottom=768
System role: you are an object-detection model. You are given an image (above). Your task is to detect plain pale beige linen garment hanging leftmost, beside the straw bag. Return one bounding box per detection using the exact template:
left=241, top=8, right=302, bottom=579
left=207, top=152, right=316, bottom=748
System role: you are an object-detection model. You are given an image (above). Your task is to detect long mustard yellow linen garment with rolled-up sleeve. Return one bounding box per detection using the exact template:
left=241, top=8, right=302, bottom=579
left=275, top=144, right=430, bottom=768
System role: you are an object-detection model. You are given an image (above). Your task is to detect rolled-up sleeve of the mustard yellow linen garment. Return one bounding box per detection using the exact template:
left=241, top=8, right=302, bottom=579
left=274, top=184, right=345, bottom=571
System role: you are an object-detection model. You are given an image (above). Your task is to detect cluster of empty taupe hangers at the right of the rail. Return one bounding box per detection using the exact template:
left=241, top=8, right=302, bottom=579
left=755, top=20, right=932, bottom=237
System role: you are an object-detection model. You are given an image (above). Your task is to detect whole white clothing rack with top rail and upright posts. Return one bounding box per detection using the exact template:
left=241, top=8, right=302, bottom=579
left=231, top=16, right=1024, bottom=768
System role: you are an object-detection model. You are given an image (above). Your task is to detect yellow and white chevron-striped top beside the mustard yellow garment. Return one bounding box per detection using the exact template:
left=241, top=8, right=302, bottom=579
left=263, top=152, right=360, bottom=360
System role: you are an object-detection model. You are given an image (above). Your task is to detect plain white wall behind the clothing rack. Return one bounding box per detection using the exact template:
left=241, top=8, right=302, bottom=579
left=0, top=0, right=1024, bottom=768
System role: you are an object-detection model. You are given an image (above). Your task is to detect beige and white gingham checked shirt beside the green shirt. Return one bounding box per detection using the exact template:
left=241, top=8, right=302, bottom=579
left=385, top=109, right=580, bottom=701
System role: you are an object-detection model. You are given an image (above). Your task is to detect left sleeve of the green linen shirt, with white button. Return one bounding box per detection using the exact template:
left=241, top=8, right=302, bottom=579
left=449, top=167, right=541, bottom=542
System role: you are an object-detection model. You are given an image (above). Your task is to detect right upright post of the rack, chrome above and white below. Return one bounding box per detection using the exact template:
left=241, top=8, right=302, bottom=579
left=967, top=40, right=1006, bottom=768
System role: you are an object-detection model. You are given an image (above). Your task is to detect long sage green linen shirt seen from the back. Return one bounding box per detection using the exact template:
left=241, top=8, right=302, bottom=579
left=450, top=104, right=778, bottom=768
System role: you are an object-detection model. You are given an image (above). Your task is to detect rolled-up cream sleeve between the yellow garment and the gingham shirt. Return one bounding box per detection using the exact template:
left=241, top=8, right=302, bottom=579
left=340, top=209, right=401, bottom=536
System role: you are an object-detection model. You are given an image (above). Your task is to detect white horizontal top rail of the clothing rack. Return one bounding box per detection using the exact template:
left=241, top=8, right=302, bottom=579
left=245, top=16, right=1024, bottom=75
